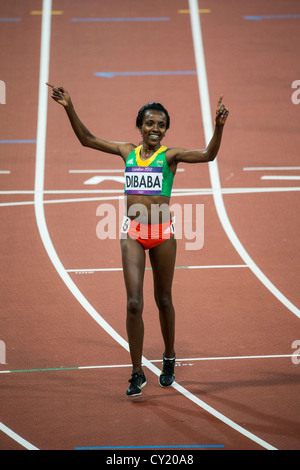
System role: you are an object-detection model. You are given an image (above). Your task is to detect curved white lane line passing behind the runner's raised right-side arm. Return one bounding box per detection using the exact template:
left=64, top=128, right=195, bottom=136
left=189, top=0, right=300, bottom=318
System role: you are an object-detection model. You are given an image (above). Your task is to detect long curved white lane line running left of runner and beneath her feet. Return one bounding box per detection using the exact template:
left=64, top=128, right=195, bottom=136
left=31, top=0, right=274, bottom=449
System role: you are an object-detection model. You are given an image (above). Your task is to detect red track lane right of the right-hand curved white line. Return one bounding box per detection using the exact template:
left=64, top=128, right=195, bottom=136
left=196, top=1, right=299, bottom=308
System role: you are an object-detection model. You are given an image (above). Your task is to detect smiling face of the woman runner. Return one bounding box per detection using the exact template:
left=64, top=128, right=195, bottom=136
left=140, top=109, right=167, bottom=148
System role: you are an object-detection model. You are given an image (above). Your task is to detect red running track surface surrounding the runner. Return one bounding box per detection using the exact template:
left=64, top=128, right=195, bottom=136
left=0, top=0, right=300, bottom=450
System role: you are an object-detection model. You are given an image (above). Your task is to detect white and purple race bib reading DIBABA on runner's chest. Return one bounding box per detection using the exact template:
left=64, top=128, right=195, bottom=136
left=125, top=167, right=163, bottom=195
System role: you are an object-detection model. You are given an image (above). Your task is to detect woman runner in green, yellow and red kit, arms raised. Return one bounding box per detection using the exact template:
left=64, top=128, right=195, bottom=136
left=47, top=83, right=229, bottom=397
